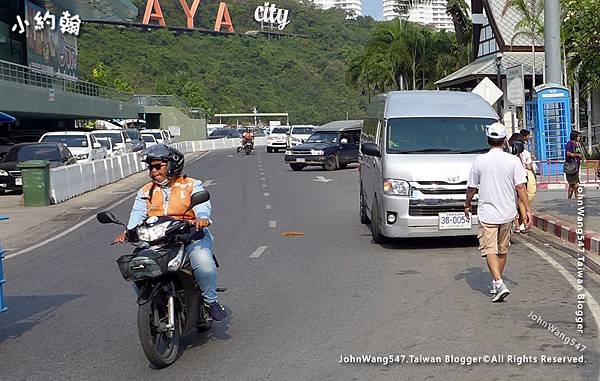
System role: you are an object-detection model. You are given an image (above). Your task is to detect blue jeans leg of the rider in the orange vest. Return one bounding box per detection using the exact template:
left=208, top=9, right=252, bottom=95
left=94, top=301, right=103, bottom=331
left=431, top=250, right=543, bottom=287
left=185, top=228, right=217, bottom=303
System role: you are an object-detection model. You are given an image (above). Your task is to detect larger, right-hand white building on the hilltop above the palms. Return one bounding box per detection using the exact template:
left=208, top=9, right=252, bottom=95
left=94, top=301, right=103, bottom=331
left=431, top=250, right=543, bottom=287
left=383, top=0, right=454, bottom=31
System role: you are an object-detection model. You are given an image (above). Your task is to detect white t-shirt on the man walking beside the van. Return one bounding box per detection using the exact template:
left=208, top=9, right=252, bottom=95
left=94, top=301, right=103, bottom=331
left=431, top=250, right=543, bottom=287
left=467, top=148, right=527, bottom=224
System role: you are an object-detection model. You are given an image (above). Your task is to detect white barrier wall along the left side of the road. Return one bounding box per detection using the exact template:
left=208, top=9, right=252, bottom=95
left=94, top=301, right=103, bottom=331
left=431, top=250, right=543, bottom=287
left=50, top=137, right=267, bottom=204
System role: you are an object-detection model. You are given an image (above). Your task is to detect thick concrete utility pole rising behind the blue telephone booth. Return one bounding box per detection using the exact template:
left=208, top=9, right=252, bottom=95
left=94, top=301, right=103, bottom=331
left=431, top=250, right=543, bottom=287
left=544, top=0, right=562, bottom=84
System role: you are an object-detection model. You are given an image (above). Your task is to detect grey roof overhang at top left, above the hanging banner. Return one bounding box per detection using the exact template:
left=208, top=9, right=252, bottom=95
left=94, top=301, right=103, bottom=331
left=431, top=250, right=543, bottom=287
left=41, top=0, right=138, bottom=21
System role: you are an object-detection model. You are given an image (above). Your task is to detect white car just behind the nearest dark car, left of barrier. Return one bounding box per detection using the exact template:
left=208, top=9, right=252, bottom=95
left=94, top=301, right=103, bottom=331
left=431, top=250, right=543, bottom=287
left=39, top=131, right=106, bottom=163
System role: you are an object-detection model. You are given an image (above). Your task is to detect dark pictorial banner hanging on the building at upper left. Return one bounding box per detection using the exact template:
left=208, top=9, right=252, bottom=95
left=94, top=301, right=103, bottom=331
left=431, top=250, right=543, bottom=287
left=25, top=1, right=78, bottom=79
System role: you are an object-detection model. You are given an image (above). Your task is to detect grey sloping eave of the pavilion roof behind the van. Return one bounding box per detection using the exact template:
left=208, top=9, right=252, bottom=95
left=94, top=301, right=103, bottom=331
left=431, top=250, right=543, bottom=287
left=435, top=52, right=544, bottom=89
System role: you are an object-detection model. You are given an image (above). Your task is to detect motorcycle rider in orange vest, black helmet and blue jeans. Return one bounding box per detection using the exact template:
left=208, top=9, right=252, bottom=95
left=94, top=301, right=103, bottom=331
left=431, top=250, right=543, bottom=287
left=115, top=144, right=227, bottom=321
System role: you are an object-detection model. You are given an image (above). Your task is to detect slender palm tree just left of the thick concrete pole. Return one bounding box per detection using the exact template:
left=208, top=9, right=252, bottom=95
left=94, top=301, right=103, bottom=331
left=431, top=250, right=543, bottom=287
left=502, top=0, right=544, bottom=87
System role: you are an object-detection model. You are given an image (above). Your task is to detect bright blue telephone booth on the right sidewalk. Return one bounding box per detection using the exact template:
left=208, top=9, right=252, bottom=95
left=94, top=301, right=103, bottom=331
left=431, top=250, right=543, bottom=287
left=526, top=84, right=571, bottom=176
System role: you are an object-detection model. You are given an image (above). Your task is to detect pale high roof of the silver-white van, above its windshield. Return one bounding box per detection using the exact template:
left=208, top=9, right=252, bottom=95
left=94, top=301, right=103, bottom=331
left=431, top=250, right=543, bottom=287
left=385, top=90, right=498, bottom=119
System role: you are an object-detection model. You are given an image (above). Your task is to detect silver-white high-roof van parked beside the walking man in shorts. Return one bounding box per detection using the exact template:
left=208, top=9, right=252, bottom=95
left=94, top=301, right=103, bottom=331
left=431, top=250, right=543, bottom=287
left=359, top=91, right=498, bottom=243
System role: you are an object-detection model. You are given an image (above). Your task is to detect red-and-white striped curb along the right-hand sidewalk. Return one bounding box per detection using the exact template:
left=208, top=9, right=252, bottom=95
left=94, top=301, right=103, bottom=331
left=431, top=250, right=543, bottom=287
left=533, top=213, right=600, bottom=254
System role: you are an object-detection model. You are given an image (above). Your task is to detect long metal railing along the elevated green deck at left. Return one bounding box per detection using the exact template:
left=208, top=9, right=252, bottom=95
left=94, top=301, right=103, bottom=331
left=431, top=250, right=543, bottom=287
left=0, top=60, right=133, bottom=102
